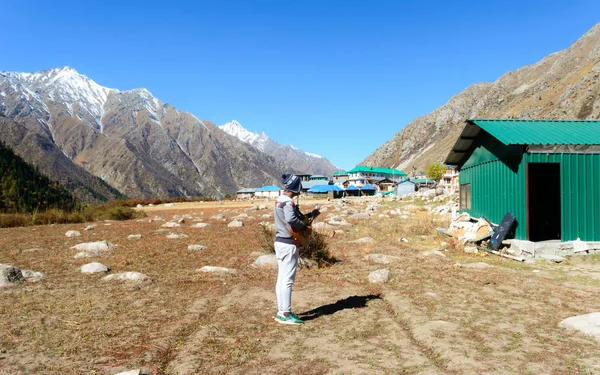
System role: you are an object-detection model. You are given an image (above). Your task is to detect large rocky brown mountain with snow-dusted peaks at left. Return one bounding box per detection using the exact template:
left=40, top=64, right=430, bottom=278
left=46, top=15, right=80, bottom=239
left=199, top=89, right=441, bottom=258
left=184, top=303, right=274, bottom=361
left=0, top=67, right=285, bottom=198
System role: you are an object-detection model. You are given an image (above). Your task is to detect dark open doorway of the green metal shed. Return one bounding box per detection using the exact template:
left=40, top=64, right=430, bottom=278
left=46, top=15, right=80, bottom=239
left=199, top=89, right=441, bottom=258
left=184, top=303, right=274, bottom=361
left=527, top=163, right=561, bottom=241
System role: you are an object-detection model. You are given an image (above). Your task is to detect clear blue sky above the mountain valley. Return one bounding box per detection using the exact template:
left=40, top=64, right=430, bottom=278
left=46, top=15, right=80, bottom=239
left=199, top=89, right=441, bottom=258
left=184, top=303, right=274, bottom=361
left=0, top=0, right=600, bottom=169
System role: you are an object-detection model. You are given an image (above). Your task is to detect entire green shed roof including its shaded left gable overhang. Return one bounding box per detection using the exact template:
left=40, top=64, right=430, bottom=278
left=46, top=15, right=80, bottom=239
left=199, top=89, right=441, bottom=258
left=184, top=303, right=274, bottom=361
left=445, top=119, right=600, bottom=166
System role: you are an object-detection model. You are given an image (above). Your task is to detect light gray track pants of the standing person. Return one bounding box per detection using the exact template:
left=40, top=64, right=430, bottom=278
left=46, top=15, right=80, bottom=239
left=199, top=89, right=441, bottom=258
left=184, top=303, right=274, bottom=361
left=275, top=242, right=298, bottom=313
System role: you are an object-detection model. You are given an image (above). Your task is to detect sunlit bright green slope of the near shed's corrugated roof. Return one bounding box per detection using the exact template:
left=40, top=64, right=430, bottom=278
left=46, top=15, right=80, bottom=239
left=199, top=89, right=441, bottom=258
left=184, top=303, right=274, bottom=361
left=469, top=119, right=600, bottom=145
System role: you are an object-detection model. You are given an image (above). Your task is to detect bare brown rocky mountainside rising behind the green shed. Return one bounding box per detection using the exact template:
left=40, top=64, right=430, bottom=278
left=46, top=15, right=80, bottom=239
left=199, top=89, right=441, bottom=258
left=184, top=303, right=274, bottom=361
left=361, top=24, right=600, bottom=173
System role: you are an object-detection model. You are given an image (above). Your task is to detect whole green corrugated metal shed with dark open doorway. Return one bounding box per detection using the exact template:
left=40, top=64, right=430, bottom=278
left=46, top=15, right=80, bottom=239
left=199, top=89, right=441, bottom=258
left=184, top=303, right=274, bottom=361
left=446, top=119, right=600, bottom=241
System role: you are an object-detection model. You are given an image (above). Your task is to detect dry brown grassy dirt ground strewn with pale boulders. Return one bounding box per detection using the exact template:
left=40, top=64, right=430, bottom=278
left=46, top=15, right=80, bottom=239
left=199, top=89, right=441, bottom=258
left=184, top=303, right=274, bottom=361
left=0, top=200, right=600, bottom=375
